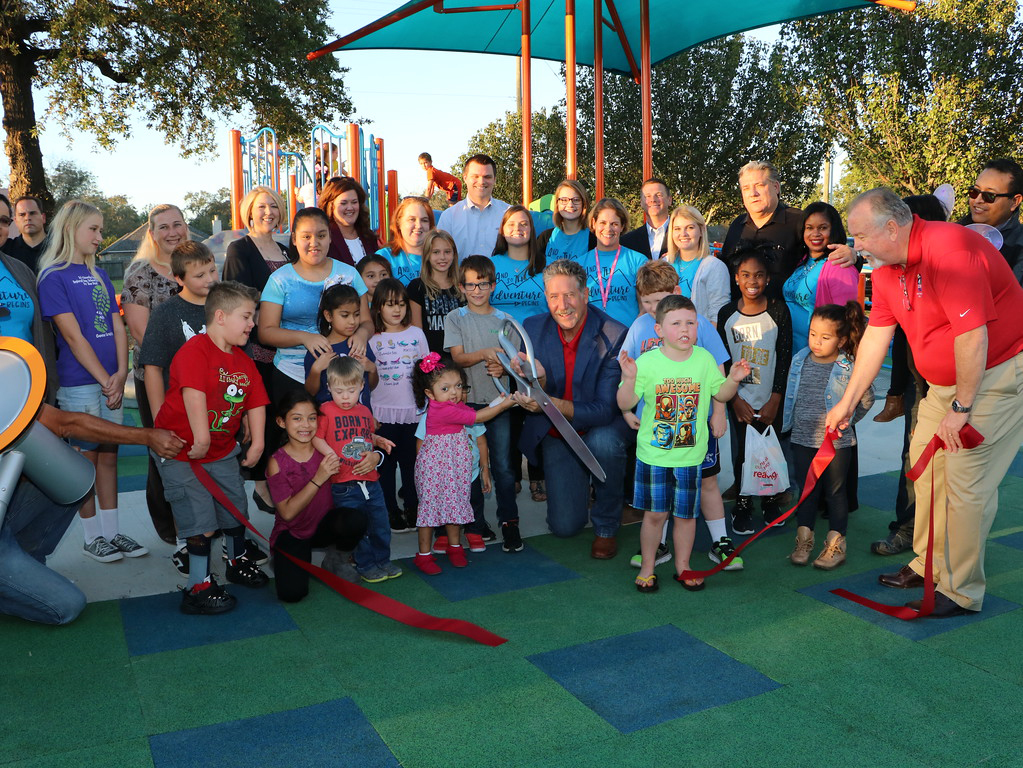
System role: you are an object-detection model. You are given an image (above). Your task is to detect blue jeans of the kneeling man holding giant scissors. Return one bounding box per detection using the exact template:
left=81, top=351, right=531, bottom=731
left=540, top=418, right=625, bottom=537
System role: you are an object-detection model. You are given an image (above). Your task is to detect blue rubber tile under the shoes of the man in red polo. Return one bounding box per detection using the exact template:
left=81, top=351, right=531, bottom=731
left=799, top=568, right=1019, bottom=640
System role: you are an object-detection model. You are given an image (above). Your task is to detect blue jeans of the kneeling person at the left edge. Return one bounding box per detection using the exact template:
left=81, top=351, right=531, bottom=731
left=0, top=480, right=85, bottom=624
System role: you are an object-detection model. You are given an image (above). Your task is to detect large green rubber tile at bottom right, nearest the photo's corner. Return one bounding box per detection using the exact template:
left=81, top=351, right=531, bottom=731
left=800, top=646, right=1023, bottom=767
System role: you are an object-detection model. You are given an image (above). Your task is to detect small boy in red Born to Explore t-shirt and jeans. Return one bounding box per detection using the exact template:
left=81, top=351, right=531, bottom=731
left=313, top=357, right=401, bottom=584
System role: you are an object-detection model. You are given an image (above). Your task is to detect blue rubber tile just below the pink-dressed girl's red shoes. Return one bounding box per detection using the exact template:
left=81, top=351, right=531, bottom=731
left=406, top=544, right=579, bottom=602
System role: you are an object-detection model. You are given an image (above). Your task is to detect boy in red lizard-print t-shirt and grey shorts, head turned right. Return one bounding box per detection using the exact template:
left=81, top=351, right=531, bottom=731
left=155, top=281, right=269, bottom=614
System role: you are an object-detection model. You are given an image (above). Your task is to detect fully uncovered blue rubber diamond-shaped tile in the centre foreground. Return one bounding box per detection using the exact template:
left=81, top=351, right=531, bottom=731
left=528, top=624, right=781, bottom=733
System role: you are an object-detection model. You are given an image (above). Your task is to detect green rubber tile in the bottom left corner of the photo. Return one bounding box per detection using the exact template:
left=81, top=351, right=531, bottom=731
left=0, top=658, right=144, bottom=763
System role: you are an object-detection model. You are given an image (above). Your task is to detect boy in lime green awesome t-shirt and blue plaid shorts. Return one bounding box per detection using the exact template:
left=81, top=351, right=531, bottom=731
left=618, top=295, right=750, bottom=592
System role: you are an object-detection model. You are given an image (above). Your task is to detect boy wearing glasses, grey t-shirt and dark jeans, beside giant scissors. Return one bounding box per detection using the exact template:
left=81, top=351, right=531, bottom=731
left=444, top=256, right=523, bottom=552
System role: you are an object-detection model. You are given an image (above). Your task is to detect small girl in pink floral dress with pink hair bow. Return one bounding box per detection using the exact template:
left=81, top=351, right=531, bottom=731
left=412, top=352, right=514, bottom=576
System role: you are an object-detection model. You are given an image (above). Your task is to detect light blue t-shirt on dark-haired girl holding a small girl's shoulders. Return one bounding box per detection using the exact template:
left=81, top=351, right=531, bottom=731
left=260, top=260, right=366, bottom=382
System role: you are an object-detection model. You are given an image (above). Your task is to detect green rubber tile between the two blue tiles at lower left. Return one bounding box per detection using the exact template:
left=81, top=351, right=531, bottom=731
left=132, top=632, right=339, bottom=733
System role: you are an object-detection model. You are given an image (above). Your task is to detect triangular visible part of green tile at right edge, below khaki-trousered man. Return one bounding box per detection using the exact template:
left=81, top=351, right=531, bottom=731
left=924, top=611, right=1023, bottom=687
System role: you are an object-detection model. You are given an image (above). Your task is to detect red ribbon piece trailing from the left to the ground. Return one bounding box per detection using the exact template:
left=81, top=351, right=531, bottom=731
left=191, top=461, right=507, bottom=647
